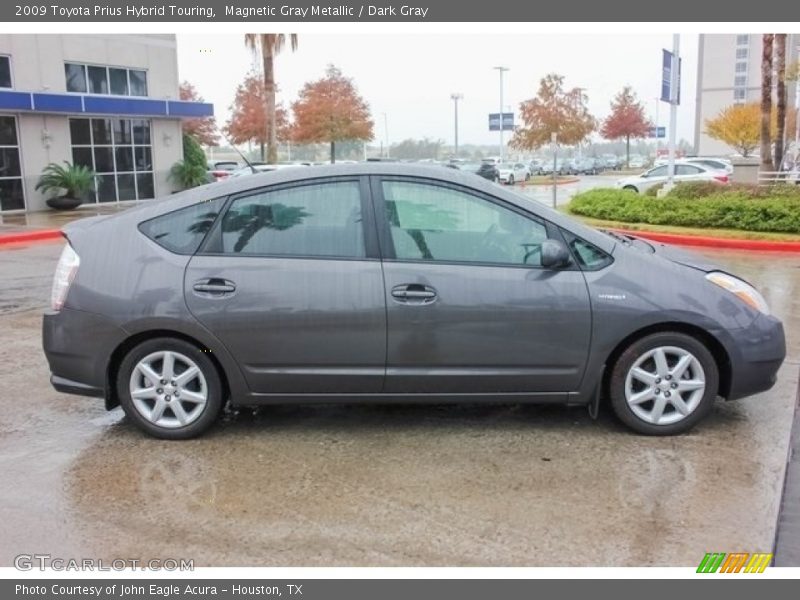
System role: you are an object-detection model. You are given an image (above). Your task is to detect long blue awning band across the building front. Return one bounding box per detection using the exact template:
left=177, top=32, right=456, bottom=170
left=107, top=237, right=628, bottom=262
left=0, top=90, right=214, bottom=119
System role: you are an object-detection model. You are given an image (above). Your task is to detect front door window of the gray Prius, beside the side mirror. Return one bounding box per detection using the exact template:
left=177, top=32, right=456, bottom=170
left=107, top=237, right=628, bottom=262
left=382, top=181, right=547, bottom=266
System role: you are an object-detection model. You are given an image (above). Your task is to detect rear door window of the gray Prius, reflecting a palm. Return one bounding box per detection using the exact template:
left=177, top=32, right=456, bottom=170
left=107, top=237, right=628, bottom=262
left=222, top=181, right=366, bottom=258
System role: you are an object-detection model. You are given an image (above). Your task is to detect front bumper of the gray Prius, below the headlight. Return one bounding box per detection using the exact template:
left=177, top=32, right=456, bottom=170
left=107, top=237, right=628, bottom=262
left=726, top=315, right=786, bottom=400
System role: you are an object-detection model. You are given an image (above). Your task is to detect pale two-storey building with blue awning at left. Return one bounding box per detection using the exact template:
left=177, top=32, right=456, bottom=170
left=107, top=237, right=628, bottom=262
left=0, top=34, right=213, bottom=213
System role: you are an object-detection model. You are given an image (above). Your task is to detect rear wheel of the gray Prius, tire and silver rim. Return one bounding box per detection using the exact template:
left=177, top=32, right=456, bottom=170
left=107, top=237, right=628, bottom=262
left=117, top=337, right=223, bottom=440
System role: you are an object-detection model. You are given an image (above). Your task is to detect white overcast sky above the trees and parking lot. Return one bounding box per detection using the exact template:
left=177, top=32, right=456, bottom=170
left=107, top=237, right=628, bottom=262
left=177, top=34, right=697, bottom=149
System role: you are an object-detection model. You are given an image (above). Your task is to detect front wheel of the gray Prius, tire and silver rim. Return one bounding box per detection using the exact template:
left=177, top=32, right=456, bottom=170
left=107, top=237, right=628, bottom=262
left=608, top=332, right=719, bottom=435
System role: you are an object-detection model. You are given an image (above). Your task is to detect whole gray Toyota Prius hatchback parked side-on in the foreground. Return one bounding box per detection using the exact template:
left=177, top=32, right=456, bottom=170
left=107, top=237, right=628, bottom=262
left=44, top=163, right=785, bottom=438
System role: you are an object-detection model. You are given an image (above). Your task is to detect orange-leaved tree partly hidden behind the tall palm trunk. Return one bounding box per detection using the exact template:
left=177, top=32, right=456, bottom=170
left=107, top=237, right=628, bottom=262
left=225, top=73, right=289, bottom=161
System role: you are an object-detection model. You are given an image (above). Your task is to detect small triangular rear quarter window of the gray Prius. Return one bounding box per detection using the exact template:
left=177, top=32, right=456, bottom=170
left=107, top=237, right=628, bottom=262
left=139, top=198, right=224, bottom=254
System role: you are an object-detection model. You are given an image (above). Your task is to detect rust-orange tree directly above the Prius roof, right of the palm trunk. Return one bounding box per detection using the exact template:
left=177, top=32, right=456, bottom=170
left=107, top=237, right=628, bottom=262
left=292, top=65, right=373, bottom=163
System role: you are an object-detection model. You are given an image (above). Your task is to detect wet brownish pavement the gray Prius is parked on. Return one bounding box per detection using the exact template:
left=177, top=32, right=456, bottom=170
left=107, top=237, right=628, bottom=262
left=0, top=244, right=800, bottom=566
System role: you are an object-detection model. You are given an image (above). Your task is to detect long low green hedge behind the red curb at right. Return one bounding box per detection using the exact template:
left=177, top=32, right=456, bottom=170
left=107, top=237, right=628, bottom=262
left=569, top=186, right=800, bottom=233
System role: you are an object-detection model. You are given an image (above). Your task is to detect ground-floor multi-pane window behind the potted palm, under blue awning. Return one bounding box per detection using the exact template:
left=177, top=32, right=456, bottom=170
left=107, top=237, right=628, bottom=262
left=69, top=119, right=155, bottom=202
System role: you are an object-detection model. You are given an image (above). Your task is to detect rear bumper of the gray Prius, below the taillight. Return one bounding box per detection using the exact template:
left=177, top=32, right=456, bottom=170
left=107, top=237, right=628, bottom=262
left=42, top=308, right=126, bottom=398
